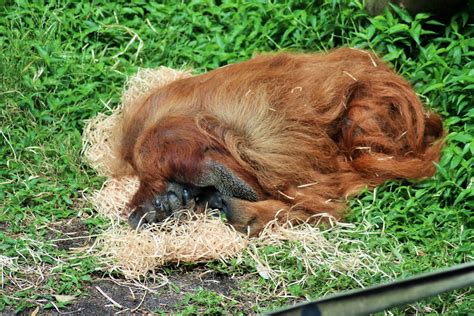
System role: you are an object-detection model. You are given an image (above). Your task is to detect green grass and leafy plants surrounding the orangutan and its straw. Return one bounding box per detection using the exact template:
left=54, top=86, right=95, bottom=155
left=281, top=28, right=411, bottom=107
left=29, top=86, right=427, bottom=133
left=0, top=1, right=474, bottom=314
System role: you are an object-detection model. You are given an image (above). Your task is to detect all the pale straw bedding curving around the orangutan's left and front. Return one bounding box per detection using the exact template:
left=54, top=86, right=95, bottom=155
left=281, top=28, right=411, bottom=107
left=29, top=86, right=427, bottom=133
left=83, top=67, right=386, bottom=285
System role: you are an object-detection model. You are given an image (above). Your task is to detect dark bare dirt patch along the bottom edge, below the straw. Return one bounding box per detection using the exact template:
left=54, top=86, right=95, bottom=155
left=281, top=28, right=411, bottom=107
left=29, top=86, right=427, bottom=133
left=9, top=267, right=251, bottom=315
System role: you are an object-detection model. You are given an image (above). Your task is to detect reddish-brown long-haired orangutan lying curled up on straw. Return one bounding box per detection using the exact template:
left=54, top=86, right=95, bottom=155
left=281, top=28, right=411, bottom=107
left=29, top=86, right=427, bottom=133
left=114, top=48, right=444, bottom=234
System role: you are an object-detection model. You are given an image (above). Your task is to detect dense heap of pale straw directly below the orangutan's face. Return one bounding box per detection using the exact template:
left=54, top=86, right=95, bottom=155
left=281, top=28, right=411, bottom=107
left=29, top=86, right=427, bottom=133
left=93, top=211, right=247, bottom=279
